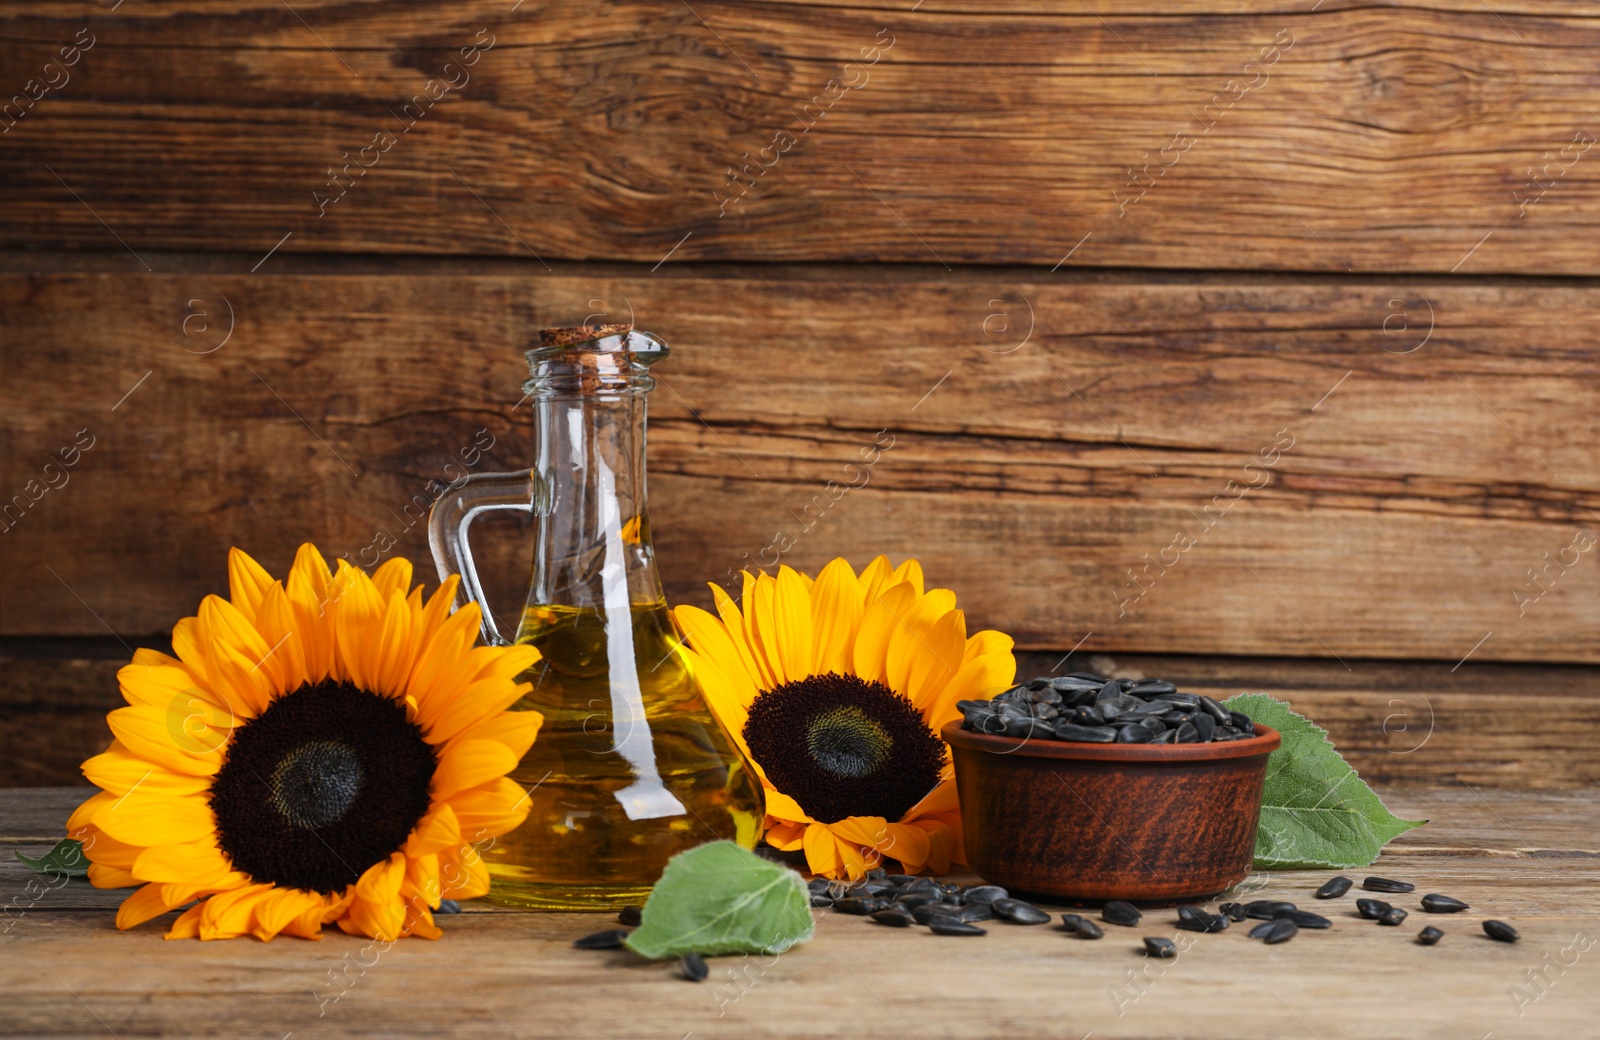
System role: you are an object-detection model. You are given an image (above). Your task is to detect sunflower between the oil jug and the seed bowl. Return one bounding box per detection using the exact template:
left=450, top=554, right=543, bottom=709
left=674, top=557, right=1016, bottom=878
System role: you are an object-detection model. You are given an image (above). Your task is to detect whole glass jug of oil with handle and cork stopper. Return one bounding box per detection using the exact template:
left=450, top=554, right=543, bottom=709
left=429, top=325, right=763, bottom=910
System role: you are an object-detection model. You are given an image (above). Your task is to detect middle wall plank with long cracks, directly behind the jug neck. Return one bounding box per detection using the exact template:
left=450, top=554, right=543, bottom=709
left=0, top=267, right=1600, bottom=664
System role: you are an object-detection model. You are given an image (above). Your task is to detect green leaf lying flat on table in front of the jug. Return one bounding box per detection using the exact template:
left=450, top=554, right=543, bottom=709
left=627, top=842, right=816, bottom=958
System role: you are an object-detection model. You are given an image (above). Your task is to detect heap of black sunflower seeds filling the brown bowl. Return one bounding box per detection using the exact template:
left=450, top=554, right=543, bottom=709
left=957, top=672, right=1256, bottom=744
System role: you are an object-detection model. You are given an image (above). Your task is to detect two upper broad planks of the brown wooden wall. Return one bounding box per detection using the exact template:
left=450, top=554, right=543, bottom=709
left=0, top=0, right=1600, bottom=782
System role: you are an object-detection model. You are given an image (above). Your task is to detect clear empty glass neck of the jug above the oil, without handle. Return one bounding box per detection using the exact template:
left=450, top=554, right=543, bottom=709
left=526, top=330, right=666, bottom=616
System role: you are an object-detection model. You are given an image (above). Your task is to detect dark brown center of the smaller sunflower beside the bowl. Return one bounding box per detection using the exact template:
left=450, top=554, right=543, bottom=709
left=744, top=672, right=944, bottom=824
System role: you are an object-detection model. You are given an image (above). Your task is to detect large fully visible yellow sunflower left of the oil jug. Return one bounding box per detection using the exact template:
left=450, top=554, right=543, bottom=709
left=67, top=544, right=542, bottom=941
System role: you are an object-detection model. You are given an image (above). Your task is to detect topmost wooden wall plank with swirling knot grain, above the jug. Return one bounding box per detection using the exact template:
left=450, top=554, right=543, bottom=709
left=0, top=0, right=1600, bottom=274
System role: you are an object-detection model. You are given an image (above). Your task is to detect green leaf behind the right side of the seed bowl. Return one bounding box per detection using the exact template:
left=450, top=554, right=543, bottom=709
left=1226, top=693, right=1427, bottom=870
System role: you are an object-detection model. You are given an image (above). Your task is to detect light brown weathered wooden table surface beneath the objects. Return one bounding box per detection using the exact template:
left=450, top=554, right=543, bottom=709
left=0, top=781, right=1600, bottom=1040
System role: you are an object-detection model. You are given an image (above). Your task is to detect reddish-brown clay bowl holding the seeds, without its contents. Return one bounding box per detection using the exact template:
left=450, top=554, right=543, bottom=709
left=942, top=718, right=1282, bottom=902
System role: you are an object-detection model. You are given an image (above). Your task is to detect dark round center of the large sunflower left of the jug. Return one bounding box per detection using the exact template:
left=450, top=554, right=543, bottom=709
left=211, top=680, right=437, bottom=893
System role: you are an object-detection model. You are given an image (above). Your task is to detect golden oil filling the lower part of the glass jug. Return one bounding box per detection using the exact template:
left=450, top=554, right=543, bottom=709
left=480, top=600, right=763, bottom=910
